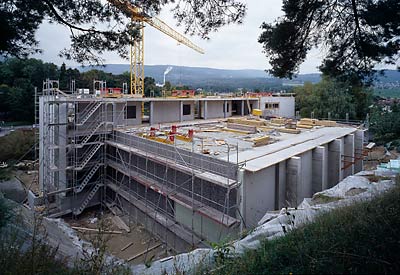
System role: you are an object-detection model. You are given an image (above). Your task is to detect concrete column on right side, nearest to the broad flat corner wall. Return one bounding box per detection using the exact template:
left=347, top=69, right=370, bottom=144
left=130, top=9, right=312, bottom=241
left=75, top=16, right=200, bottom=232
left=286, top=157, right=302, bottom=207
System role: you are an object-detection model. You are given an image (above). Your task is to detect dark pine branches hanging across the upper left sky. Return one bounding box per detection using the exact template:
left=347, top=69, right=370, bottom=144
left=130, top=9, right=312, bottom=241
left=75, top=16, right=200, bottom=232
left=0, top=0, right=246, bottom=64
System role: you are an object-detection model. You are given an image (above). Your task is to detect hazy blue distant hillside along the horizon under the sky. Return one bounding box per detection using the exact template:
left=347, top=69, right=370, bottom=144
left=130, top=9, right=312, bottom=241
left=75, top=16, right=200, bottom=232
left=78, top=64, right=400, bottom=91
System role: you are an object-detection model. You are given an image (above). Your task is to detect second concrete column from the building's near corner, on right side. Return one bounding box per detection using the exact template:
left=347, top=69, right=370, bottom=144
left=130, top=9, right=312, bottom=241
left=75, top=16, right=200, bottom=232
left=312, top=145, right=328, bottom=194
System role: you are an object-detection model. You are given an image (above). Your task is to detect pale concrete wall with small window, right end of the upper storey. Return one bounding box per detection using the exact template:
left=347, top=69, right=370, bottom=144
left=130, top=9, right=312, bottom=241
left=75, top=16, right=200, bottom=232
left=260, top=96, right=295, bottom=117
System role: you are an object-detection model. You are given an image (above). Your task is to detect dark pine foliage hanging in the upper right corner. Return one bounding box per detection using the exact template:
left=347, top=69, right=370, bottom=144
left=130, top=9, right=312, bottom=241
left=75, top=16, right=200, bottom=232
left=259, top=0, right=400, bottom=80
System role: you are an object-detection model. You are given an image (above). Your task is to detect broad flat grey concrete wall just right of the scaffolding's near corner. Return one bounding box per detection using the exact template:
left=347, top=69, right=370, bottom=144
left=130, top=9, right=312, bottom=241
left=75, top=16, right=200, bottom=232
left=242, top=166, right=275, bottom=227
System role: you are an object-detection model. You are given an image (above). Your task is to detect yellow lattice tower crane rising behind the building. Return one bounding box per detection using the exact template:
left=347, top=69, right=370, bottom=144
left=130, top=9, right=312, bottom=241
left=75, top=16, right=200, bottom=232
left=108, top=0, right=204, bottom=96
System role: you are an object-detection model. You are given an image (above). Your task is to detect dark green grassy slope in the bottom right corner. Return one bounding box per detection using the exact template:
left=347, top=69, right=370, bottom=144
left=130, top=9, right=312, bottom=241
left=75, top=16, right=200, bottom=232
left=209, top=178, right=400, bottom=275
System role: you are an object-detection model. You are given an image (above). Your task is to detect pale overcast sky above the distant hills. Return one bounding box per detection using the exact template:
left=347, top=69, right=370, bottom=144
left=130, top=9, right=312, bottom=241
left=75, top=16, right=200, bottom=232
left=35, top=0, right=321, bottom=73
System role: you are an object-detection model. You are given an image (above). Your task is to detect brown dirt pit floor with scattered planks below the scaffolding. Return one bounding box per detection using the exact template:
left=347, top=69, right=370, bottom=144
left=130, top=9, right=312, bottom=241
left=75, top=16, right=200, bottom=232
left=65, top=210, right=172, bottom=264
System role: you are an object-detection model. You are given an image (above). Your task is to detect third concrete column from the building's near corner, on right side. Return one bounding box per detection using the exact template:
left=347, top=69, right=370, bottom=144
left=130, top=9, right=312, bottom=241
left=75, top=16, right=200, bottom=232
left=328, top=139, right=342, bottom=188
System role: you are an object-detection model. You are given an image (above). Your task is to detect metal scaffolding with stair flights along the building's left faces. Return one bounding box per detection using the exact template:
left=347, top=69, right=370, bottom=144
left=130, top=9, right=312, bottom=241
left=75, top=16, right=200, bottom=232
left=38, top=86, right=242, bottom=252
